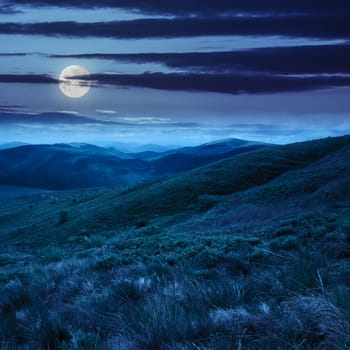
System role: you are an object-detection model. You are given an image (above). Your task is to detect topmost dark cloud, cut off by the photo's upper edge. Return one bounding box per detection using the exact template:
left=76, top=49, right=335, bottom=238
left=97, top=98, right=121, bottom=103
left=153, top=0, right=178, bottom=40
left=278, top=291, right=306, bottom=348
left=7, top=0, right=350, bottom=15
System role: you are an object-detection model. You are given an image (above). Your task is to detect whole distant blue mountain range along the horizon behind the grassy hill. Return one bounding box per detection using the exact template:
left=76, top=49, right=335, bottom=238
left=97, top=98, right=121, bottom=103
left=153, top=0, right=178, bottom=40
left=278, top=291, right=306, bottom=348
left=0, top=139, right=267, bottom=190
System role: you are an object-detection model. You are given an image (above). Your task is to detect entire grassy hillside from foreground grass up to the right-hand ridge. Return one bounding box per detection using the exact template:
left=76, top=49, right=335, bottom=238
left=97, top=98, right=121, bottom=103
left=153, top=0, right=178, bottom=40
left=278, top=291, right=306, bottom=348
left=0, top=137, right=350, bottom=350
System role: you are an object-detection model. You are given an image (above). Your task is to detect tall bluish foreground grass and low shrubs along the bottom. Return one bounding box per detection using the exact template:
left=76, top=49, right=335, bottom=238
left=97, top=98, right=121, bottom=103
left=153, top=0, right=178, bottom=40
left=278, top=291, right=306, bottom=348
left=0, top=205, right=350, bottom=350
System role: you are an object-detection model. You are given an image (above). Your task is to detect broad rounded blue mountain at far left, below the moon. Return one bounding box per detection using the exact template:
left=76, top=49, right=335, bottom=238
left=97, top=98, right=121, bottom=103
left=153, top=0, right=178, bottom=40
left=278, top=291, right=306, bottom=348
left=0, top=144, right=152, bottom=190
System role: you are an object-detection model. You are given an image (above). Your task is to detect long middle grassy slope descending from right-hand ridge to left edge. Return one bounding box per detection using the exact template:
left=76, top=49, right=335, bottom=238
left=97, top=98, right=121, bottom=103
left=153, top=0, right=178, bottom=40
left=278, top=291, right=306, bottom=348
left=0, top=137, right=350, bottom=243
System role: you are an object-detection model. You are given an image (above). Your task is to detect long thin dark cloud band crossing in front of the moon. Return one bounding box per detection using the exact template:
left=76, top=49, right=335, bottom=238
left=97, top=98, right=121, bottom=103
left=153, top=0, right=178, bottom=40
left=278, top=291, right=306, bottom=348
left=0, top=73, right=350, bottom=94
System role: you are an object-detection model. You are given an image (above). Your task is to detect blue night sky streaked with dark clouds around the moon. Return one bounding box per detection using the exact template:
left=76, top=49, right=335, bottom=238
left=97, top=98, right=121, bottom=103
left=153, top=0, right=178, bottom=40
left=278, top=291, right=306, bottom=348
left=0, top=0, right=350, bottom=146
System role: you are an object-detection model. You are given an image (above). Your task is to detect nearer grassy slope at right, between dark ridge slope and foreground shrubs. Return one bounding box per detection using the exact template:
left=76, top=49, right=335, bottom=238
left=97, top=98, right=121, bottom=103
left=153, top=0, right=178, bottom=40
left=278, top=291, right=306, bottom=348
left=182, top=146, right=350, bottom=233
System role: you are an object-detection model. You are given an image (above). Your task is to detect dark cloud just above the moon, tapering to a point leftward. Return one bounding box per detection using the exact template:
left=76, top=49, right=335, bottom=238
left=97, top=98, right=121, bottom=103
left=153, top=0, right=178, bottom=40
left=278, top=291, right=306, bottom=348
left=50, top=45, right=350, bottom=74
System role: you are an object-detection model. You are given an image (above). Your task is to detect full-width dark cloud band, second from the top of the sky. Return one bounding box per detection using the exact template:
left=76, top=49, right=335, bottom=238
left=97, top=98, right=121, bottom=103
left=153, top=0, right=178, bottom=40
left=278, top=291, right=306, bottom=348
left=0, top=15, right=350, bottom=39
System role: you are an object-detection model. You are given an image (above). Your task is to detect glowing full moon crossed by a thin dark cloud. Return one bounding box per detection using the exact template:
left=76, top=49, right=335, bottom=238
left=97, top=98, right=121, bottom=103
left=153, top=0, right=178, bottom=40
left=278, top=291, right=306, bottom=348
left=59, top=65, right=90, bottom=98
